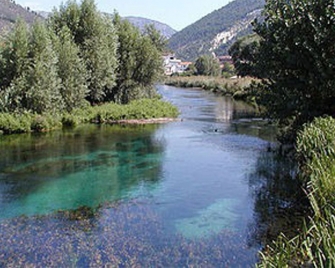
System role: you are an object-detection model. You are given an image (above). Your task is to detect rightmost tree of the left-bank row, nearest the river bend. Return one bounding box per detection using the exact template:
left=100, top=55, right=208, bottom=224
left=113, top=14, right=163, bottom=103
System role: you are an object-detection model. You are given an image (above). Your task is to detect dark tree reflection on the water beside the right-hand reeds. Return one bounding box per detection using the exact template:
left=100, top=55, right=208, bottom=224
left=247, top=151, right=308, bottom=245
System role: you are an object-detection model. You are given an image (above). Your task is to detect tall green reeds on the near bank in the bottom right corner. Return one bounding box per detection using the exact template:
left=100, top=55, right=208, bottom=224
left=259, top=117, right=335, bottom=267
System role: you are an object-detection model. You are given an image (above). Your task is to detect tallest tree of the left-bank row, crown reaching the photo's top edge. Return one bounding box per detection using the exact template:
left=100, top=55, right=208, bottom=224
left=49, top=0, right=118, bottom=103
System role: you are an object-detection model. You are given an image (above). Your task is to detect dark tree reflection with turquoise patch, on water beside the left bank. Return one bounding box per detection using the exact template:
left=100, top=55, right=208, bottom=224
left=0, top=126, right=164, bottom=218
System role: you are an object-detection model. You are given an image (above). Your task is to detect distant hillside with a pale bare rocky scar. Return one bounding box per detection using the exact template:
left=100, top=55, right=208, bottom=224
left=169, top=0, right=265, bottom=61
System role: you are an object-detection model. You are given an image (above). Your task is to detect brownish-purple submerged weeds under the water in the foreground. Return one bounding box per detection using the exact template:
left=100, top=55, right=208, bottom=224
left=0, top=199, right=254, bottom=267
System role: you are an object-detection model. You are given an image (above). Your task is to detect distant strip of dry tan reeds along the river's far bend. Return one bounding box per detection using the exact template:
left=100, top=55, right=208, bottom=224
left=164, top=76, right=254, bottom=101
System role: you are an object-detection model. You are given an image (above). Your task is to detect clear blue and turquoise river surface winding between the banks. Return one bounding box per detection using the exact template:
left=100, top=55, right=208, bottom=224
left=0, top=86, right=284, bottom=267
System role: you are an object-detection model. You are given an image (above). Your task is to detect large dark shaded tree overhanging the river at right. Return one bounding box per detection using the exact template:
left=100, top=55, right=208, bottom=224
left=233, top=0, right=335, bottom=142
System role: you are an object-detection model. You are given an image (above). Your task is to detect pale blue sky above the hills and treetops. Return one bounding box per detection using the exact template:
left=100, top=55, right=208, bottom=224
left=15, top=0, right=231, bottom=31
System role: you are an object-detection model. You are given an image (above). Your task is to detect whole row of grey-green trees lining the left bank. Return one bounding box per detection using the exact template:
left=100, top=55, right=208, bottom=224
left=0, top=0, right=165, bottom=114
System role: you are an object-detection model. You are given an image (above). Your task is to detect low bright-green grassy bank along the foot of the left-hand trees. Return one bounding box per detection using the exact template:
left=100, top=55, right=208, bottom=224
left=0, top=99, right=178, bottom=134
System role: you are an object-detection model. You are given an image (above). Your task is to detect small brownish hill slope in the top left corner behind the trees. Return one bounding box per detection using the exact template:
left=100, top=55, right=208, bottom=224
left=0, top=0, right=39, bottom=32
